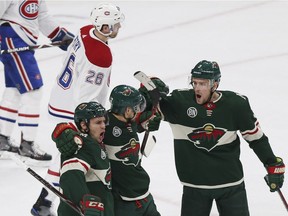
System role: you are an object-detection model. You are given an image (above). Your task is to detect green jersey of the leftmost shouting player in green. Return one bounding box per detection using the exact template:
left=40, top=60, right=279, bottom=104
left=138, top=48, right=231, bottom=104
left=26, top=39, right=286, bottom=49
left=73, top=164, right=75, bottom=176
left=58, top=134, right=114, bottom=216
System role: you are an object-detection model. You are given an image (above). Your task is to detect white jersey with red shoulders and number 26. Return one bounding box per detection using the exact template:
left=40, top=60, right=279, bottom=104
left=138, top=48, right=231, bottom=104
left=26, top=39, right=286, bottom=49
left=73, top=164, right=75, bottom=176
left=48, top=25, right=112, bottom=119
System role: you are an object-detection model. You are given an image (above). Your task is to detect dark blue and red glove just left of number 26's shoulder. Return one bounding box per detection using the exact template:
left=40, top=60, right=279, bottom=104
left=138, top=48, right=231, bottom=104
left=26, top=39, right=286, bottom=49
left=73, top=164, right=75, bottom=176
left=48, top=27, right=75, bottom=51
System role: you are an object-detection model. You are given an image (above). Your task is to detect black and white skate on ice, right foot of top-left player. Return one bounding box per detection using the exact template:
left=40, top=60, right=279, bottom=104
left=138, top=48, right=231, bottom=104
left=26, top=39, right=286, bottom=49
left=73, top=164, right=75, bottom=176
left=18, top=140, right=52, bottom=166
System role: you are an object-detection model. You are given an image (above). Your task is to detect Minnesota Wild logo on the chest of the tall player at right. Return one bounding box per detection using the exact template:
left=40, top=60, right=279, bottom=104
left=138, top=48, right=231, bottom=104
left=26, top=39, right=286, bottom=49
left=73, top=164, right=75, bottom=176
left=188, top=124, right=227, bottom=152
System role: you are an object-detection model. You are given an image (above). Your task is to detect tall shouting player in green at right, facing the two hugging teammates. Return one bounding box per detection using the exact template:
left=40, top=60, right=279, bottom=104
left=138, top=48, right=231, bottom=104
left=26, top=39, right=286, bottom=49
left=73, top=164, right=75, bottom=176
left=142, top=60, right=285, bottom=216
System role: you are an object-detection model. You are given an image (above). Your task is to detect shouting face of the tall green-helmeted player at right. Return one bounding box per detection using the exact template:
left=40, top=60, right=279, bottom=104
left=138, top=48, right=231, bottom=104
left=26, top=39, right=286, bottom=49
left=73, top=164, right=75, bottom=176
left=192, top=78, right=211, bottom=104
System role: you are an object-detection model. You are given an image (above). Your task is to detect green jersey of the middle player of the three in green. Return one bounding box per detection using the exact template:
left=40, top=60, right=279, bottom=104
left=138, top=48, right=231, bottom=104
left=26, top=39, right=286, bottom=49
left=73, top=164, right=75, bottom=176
left=104, top=112, right=150, bottom=201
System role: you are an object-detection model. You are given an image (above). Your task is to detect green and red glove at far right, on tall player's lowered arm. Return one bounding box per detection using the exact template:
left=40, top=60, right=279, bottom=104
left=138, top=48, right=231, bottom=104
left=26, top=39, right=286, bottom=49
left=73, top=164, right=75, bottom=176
left=264, top=157, right=285, bottom=192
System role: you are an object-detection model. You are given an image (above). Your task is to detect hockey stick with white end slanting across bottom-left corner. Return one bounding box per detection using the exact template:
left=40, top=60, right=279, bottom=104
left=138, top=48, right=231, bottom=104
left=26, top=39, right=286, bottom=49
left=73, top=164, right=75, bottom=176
left=9, top=155, right=84, bottom=216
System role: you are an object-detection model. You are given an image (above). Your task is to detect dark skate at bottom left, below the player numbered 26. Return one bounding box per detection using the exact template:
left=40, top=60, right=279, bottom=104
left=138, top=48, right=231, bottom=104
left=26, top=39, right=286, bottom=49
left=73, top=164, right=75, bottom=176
left=31, top=188, right=56, bottom=216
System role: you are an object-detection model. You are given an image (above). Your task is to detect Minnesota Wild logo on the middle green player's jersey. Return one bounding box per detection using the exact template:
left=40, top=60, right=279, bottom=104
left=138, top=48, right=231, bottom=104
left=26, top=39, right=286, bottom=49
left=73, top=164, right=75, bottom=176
left=115, top=139, right=140, bottom=166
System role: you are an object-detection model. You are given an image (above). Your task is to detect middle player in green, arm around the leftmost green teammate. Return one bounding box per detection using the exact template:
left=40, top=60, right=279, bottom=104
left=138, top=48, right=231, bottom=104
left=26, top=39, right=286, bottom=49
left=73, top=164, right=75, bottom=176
left=56, top=85, right=160, bottom=216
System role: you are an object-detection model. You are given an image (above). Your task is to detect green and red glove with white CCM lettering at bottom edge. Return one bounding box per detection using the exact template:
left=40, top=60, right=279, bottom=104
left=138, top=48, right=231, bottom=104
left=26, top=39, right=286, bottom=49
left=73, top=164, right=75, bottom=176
left=80, top=194, right=104, bottom=216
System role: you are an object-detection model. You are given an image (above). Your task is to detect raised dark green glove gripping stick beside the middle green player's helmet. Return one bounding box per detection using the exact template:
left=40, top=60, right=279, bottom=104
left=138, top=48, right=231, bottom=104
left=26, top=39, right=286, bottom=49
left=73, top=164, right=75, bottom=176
left=139, top=77, right=169, bottom=109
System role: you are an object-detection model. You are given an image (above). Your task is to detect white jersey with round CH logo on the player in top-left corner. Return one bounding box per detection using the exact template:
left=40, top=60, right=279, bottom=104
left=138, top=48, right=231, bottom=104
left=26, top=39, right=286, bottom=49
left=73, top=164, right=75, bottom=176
left=0, top=0, right=59, bottom=45
